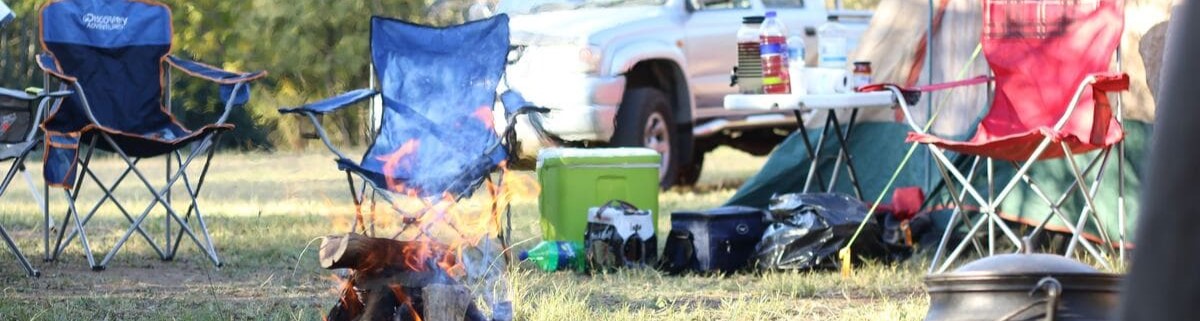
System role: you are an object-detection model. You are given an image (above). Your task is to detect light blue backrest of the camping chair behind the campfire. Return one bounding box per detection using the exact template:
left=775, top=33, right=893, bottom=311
left=362, top=14, right=509, bottom=195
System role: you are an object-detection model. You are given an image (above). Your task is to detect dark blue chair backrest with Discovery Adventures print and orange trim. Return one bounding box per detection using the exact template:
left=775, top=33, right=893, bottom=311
left=40, top=0, right=174, bottom=134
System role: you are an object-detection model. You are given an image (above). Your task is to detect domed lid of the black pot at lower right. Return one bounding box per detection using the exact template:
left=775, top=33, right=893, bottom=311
left=950, top=253, right=1099, bottom=274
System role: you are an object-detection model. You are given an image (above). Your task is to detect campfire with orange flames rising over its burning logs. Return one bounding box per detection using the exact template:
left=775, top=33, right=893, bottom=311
left=319, top=152, right=538, bottom=321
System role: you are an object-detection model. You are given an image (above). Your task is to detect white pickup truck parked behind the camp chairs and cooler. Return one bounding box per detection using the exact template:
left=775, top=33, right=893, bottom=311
left=496, top=0, right=870, bottom=187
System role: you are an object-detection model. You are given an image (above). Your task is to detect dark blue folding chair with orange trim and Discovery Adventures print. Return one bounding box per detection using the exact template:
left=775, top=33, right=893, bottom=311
left=37, top=0, right=266, bottom=271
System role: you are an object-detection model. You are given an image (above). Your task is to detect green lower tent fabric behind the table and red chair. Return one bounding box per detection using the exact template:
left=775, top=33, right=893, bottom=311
left=726, top=121, right=1153, bottom=246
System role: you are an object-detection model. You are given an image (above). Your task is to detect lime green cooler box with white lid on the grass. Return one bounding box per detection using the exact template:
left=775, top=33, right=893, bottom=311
left=538, top=147, right=661, bottom=242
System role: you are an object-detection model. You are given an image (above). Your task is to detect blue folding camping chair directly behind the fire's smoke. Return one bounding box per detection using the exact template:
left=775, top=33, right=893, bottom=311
left=280, top=14, right=547, bottom=242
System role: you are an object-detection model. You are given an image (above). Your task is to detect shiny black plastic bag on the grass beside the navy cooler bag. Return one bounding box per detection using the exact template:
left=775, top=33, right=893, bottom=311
left=755, top=194, right=892, bottom=269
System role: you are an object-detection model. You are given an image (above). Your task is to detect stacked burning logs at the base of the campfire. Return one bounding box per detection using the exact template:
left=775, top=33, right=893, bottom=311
left=319, top=234, right=485, bottom=321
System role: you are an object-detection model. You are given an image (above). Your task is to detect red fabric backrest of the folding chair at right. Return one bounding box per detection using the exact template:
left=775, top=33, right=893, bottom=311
left=980, top=0, right=1124, bottom=138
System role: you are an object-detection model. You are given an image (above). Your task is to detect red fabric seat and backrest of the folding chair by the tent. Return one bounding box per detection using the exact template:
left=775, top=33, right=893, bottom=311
left=910, top=0, right=1124, bottom=161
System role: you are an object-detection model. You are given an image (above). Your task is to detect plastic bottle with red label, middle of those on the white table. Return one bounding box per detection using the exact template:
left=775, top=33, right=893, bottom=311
left=758, top=11, right=792, bottom=93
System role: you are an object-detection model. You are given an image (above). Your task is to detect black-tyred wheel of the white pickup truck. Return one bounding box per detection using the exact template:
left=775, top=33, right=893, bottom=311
left=611, top=87, right=683, bottom=188
